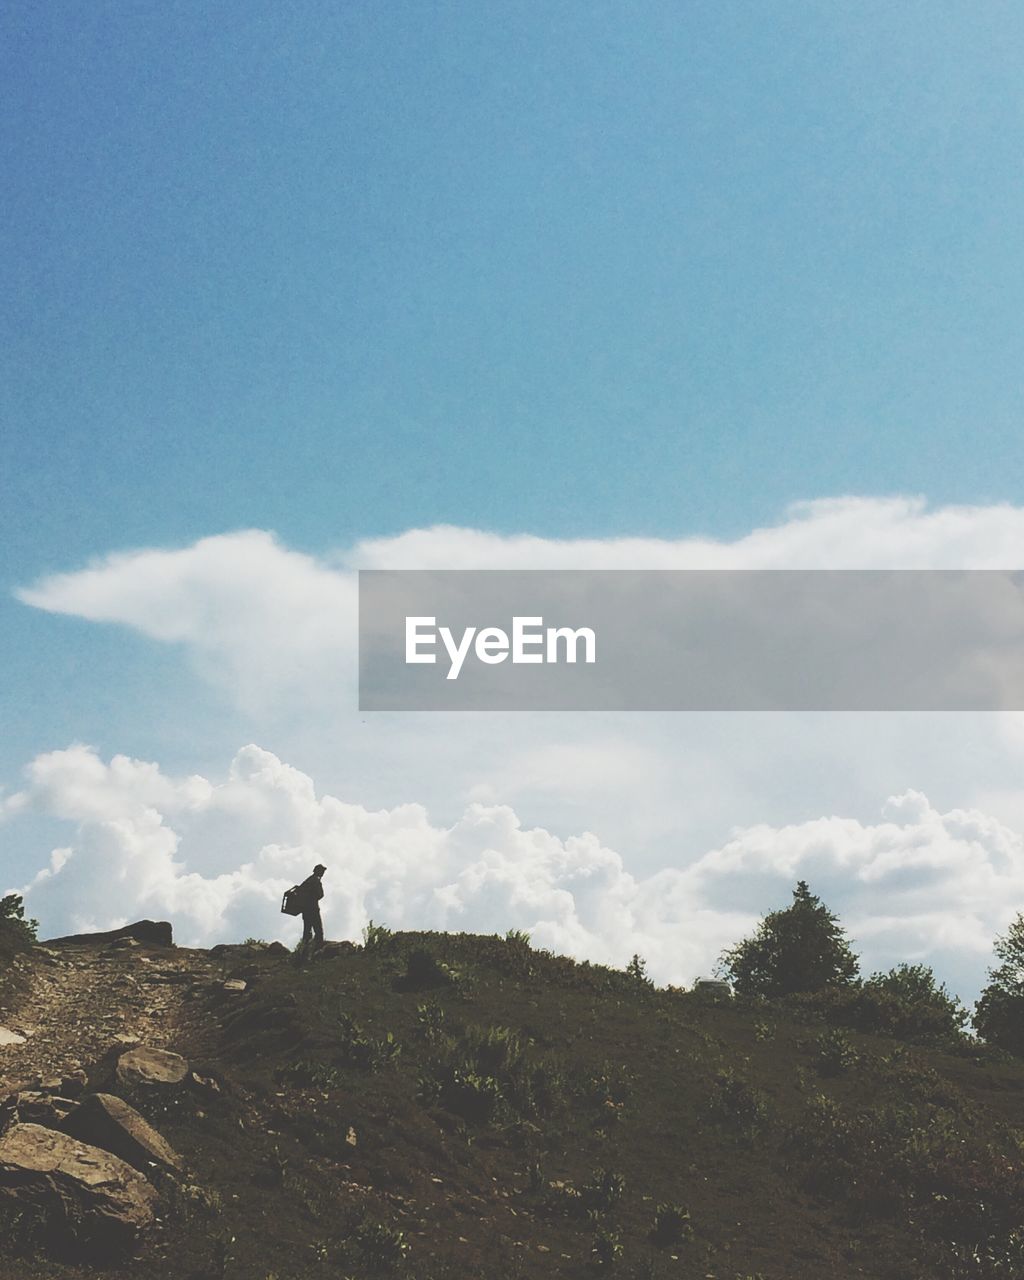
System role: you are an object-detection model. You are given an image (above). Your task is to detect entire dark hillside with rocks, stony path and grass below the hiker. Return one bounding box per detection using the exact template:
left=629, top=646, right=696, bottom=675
left=0, top=925, right=1024, bottom=1280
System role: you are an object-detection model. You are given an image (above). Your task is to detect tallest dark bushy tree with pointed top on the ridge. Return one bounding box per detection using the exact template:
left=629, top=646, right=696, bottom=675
left=718, top=881, right=858, bottom=996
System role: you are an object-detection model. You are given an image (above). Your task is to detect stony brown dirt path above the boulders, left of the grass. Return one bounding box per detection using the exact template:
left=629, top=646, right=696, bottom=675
left=0, top=942, right=220, bottom=1096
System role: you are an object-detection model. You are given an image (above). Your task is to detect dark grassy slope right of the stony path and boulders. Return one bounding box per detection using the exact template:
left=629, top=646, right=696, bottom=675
left=0, top=933, right=1024, bottom=1280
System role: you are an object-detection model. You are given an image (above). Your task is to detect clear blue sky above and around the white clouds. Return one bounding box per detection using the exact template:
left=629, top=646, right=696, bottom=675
left=0, top=0, right=1024, bottom=988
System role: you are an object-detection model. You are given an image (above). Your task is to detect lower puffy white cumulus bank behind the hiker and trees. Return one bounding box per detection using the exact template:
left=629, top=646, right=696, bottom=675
left=5, top=745, right=1024, bottom=989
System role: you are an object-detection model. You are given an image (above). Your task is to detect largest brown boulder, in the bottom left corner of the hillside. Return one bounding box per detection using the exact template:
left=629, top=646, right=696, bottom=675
left=0, top=1124, right=156, bottom=1254
